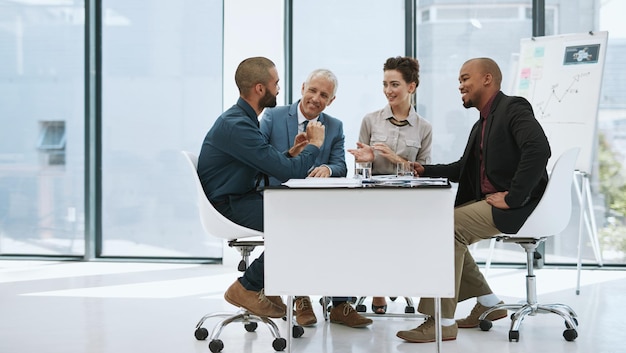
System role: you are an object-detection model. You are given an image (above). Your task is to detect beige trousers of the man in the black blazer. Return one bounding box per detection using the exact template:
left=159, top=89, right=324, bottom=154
left=417, top=200, right=500, bottom=319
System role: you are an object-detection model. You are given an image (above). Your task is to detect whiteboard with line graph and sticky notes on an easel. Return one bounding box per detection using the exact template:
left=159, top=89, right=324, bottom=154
left=513, top=32, right=608, bottom=173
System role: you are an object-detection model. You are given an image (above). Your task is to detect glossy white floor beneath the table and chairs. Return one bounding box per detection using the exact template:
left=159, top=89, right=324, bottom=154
left=0, top=260, right=626, bottom=353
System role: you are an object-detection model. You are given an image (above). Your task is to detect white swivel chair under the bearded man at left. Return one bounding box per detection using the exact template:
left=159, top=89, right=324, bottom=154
left=183, top=151, right=288, bottom=353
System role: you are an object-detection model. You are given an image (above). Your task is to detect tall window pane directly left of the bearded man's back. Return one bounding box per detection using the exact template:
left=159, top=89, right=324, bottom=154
left=101, top=0, right=222, bottom=258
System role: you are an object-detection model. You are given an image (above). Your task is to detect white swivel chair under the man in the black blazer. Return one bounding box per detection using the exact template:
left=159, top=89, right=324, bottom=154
left=479, top=148, right=580, bottom=341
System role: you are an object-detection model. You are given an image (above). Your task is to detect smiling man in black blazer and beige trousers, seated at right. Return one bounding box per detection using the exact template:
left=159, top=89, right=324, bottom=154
left=397, top=58, right=550, bottom=343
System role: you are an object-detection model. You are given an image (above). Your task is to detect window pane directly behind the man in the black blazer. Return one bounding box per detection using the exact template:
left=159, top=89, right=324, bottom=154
left=416, top=0, right=532, bottom=261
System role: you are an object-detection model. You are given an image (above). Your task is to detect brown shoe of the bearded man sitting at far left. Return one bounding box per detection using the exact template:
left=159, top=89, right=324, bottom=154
left=224, top=280, right=286, bottom=318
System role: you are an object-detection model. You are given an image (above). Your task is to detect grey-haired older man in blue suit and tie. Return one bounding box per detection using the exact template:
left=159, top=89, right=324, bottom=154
left=260, top=69, right=372, bottom=327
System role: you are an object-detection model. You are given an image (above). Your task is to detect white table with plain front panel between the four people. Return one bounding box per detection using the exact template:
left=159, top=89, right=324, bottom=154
left=264, top=182, right=455, bottom=352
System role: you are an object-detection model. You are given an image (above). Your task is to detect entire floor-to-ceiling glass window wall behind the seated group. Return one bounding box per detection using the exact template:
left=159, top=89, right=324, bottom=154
left=0, top=0, right=626, bottom=264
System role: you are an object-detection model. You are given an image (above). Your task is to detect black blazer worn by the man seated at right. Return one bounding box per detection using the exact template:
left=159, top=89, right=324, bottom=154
left=424, top=92, right=551, bottom=233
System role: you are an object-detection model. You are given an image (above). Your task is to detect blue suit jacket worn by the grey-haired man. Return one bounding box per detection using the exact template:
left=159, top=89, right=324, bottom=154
left=261, top=101, right=347, bottom=185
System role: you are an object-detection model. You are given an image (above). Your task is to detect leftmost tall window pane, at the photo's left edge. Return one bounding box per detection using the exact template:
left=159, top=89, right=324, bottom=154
left=0, top=0, right=84, bottom=256
